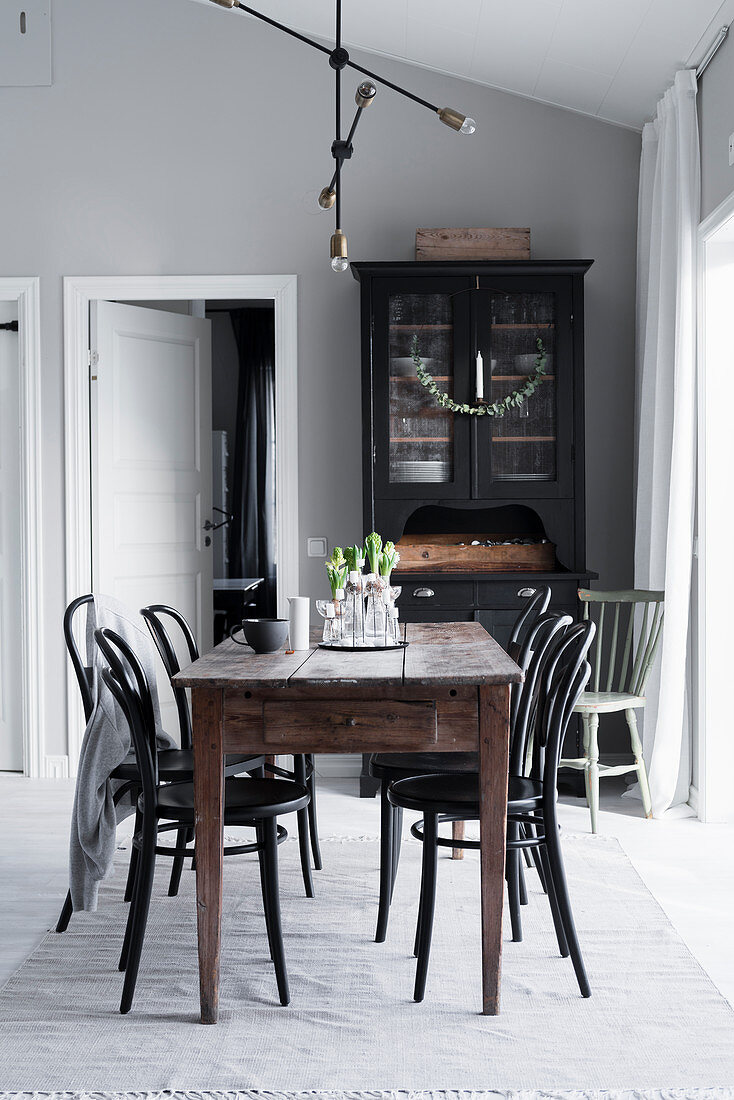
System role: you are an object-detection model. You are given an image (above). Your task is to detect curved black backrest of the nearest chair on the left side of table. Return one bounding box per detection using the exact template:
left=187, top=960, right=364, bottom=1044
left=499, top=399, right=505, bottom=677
left=95, top=629, right=158, bottom=805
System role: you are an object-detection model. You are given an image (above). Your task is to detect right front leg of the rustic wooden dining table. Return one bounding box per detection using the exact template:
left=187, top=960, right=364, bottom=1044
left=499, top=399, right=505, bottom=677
left=479, top=684, right=510, bottom=1016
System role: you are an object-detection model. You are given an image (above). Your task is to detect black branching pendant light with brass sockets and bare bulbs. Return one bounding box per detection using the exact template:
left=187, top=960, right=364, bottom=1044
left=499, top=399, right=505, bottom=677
left=211, top=0, right=476, bottom=272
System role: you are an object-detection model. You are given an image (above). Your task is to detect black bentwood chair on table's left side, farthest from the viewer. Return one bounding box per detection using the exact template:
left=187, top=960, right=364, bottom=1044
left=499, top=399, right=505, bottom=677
left=140, top=604, right=321, bottom=898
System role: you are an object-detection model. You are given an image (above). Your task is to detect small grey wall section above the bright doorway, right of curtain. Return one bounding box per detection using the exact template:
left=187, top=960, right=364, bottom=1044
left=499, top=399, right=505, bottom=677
left=698, top=32, right=734, bottom=218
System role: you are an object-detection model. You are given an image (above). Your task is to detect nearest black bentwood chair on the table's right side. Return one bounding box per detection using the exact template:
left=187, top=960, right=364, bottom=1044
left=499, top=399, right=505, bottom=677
left=388, top=623, right=594, bottom=1001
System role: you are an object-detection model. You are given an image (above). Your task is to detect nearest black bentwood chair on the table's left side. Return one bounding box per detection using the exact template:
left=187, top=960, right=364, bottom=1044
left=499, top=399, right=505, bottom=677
left=95, top=630, right=308, bottom=1013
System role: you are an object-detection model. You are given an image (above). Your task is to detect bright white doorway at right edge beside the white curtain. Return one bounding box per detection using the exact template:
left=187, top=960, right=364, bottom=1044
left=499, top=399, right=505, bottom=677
left=692, top=194, right=734, bottom=822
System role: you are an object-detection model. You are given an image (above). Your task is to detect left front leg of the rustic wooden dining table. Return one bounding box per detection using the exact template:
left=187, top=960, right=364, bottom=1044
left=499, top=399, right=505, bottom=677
left=191, top=688, right=224, bottom=1024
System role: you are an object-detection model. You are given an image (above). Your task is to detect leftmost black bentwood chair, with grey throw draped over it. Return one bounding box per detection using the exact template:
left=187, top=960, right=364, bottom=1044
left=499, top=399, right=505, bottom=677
left=56, top=593, right=265, bottom=933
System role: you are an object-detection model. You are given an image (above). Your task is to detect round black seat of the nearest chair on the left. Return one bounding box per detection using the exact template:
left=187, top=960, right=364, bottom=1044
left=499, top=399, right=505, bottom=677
left=149, top=778, right=309, bottom=825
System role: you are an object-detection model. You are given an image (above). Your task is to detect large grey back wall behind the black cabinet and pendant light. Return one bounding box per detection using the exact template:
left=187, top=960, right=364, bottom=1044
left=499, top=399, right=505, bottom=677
left=0, top=0, right=639, bottom=752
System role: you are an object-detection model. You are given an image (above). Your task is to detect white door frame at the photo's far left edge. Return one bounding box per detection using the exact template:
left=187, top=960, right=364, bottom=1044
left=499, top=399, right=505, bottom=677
left=0, top=276, right=48, bottom=779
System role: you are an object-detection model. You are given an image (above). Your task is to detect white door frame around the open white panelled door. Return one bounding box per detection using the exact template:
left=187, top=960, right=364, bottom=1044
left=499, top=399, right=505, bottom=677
left=64, top=275, right=299, bottom=773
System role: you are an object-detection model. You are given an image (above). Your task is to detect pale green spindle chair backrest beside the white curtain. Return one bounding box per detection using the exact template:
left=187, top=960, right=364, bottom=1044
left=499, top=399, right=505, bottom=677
left=579, top=589, right=665, bottom=695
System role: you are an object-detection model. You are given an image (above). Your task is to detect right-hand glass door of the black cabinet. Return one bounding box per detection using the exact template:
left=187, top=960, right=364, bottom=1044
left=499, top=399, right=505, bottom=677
left=474, top=278, right=572, bottom=497
